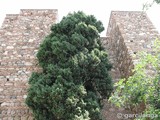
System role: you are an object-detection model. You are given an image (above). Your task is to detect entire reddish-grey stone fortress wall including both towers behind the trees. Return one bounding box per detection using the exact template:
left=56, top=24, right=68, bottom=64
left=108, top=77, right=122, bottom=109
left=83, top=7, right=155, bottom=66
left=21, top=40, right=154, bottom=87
left=0, top=9, right=159, bottom=120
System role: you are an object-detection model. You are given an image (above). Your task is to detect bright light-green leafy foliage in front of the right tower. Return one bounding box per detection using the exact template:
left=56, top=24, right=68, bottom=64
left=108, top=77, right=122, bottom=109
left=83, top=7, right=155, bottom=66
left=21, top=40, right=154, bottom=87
left=110, top=40, right=160, bottom=120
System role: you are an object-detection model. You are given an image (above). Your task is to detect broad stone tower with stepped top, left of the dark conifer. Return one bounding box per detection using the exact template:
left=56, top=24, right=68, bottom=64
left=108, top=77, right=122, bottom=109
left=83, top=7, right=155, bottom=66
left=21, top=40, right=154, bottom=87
left=0, top=9, right=57, bottom=120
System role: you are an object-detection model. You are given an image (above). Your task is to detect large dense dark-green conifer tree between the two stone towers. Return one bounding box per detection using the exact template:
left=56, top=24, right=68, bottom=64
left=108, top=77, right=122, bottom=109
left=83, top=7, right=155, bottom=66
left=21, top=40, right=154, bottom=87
left=26, top=12, right=112, bottom=120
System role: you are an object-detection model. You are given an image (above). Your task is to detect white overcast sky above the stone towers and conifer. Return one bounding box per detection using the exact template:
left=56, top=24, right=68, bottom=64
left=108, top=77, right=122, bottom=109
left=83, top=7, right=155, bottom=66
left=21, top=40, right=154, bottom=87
left=0, top=0, right=160, bottom=36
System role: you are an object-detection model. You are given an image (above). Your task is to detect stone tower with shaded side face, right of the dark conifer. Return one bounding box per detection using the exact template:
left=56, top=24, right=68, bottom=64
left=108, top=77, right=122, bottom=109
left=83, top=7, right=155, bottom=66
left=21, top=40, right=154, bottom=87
left=105, top=11, right=160, bottom=78
